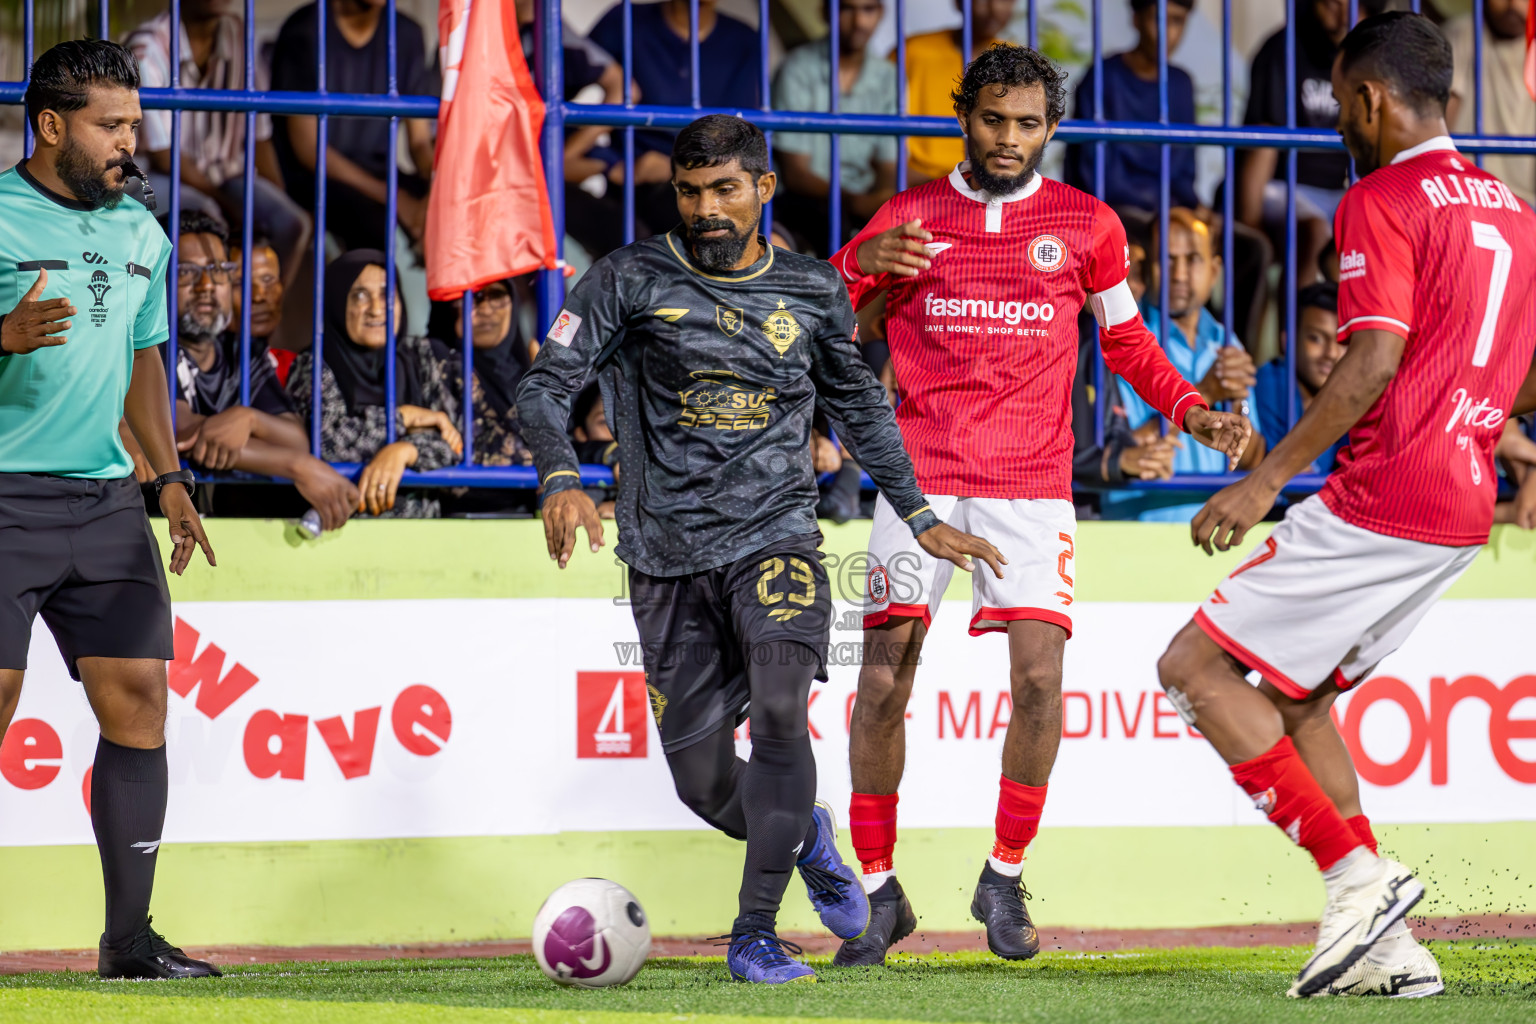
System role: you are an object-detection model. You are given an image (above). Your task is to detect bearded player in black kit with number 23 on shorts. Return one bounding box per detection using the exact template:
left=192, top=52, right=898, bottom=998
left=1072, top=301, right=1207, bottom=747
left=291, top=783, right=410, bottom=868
left=518, top=115, right=1003, bottom=984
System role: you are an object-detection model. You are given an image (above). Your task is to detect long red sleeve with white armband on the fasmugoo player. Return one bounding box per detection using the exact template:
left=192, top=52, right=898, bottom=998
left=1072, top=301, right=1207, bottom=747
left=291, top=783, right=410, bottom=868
left=1084, top=203, right=1207, bottom=428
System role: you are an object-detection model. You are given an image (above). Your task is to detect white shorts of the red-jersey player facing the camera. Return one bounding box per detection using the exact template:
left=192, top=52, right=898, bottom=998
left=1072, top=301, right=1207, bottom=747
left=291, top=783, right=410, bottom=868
left=863, top=494, right=1077, bottom=637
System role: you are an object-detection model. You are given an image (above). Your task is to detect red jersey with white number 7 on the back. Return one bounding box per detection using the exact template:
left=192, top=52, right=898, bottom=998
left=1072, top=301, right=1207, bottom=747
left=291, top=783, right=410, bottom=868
left=1321, top=137, right=1536, bottom=547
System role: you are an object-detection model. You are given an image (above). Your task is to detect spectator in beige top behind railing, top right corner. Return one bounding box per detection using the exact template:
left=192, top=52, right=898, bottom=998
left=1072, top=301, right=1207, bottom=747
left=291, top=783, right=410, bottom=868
left=1445, top=0, right=1536, bottom=206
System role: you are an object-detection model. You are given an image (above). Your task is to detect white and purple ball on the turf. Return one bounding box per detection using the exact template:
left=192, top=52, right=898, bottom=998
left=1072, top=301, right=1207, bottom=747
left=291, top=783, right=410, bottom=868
left=533, top=878, right=651, bottom=989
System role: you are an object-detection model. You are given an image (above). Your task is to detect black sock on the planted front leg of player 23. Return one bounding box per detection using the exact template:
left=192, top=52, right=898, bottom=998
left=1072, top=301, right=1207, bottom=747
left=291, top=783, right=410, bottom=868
left=731, top=735, right=816, bottom=935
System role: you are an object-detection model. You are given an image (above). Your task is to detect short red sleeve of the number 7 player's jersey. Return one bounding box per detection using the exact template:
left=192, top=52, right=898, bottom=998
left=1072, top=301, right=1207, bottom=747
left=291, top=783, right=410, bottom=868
left=1333, top=186, right=1415, bottom=341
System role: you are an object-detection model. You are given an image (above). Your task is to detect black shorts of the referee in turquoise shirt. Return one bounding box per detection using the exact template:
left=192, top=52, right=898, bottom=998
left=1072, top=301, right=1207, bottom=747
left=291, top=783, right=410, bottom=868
left=0, top=473, right=175, bottom=680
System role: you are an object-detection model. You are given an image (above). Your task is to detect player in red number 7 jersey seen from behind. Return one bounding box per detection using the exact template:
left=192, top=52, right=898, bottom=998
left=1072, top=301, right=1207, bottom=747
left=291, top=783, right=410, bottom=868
left=1158, top=12, right=1536, bottom=996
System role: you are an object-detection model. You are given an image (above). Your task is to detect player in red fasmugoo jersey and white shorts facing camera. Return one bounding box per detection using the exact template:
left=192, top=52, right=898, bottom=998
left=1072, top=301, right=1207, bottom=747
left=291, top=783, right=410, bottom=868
left=833, top=43, right=1250, bottom=964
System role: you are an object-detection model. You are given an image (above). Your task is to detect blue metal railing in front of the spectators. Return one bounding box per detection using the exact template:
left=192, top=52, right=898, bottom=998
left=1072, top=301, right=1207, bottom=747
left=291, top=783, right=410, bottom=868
left=0, top=0, right=1536, bottom=503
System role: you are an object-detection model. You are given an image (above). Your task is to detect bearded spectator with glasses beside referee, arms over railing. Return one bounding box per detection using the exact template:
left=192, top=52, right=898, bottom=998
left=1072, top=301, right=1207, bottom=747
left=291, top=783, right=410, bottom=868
left=154, top=210, right=358, bottom=530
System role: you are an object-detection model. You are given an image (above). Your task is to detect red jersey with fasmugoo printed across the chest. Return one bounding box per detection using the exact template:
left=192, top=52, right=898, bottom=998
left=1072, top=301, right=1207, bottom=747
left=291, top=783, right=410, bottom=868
left=831, top=164, right=1206, bottom=499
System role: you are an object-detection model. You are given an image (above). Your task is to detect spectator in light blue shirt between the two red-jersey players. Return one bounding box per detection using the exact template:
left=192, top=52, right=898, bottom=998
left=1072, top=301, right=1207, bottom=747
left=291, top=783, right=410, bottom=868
left=1103, top=207, right=1267, bottom=522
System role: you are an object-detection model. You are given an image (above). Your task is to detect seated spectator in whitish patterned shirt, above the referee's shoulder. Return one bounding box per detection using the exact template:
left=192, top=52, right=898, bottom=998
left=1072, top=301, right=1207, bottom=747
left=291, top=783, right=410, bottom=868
left=124, top=0, right=310, bottom=287
